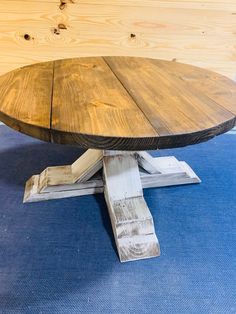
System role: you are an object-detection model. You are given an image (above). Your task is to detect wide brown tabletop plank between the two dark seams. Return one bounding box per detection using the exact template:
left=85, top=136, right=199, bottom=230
left=51, top=57, right=159, bottom=147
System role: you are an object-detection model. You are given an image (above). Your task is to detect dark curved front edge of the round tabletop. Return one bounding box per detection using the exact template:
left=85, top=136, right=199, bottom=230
left=0, top=111, right=236, bottom=151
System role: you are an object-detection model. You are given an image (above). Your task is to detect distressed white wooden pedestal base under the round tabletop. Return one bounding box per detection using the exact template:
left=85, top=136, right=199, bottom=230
left=24, top=149, right=200, bottom=262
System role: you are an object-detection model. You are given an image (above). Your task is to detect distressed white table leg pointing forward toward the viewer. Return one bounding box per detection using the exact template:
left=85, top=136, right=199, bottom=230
left=103, top=152, right=160, bottom=262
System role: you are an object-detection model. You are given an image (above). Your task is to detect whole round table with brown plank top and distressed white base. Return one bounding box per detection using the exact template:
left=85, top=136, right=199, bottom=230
left=0, top=57, right=236, bottom=261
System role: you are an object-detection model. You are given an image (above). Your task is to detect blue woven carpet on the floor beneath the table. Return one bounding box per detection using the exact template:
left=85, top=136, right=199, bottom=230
left=0, top=126, right=236, bottom=314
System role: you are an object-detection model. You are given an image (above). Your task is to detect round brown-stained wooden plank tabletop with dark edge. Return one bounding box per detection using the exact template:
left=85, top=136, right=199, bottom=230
left=0, top=57, right=236, bottom=150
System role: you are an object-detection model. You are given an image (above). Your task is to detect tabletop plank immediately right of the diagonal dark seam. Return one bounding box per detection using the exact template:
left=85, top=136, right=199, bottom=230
left=104, top=57, right=236, bottom=134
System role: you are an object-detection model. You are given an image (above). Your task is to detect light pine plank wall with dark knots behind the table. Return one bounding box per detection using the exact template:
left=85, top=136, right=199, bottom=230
left=0, top=0, right=236, bottom=78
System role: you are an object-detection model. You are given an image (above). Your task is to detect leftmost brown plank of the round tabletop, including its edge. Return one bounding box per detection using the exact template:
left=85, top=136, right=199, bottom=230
left=0, top=62, right=53, bottom=141
